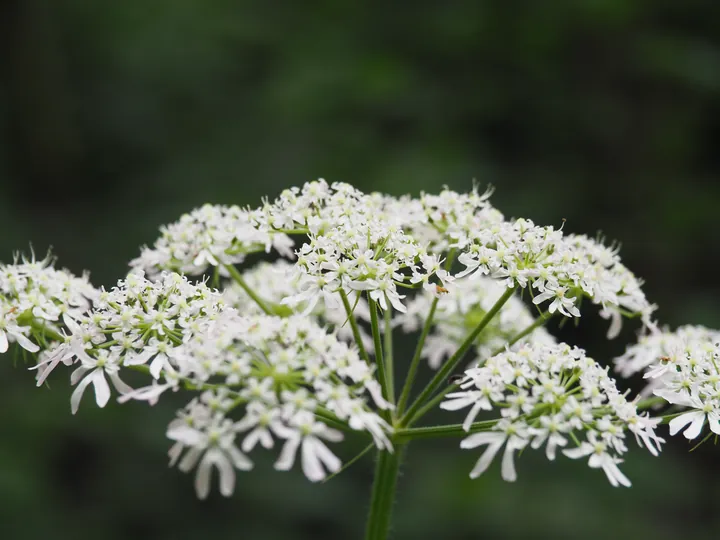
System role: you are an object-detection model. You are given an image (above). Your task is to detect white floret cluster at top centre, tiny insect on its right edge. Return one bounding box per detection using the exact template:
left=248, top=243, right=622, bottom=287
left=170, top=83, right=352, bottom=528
left=263, top=181, right=452, bottom=313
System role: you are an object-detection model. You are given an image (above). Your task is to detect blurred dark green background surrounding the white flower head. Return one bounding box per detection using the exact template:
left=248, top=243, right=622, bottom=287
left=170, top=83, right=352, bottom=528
left=0, top=0, right=720, bottom=540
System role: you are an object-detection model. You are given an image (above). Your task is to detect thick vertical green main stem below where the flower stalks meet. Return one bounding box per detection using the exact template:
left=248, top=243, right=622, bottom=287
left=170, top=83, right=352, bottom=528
left=365, top=444, right=404, bottom=540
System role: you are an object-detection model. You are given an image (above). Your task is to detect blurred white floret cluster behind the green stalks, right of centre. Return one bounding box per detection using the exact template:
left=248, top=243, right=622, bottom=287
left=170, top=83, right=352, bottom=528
left=393, top=276, right=555, bottom=369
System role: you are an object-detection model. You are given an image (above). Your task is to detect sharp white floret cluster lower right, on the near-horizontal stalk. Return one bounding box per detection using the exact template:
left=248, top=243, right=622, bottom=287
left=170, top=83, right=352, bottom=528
left=441, top=344, right=663, bottom=486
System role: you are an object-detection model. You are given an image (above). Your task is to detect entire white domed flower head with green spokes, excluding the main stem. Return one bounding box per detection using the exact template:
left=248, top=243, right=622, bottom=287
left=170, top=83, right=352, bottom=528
left=0, top=180, right=720, bottom=520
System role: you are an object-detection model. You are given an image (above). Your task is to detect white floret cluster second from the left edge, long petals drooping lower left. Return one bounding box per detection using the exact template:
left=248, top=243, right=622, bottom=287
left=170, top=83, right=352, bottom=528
left=37, top=271, right=223, bottom=414
